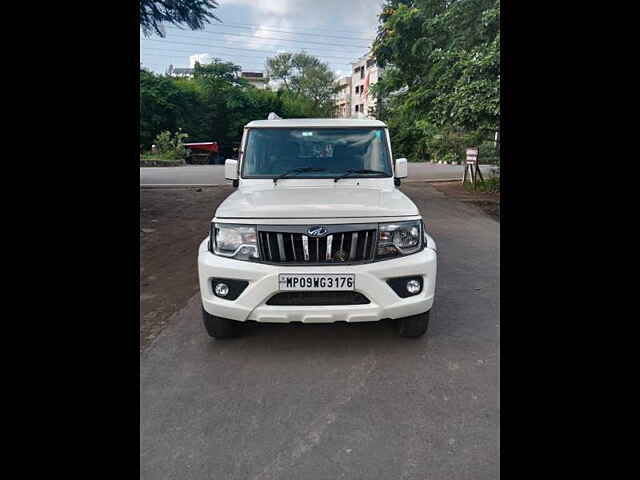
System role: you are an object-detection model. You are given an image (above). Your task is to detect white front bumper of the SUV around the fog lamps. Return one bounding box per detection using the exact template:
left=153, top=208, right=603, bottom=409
left=198, top=238, right=437, bottom=323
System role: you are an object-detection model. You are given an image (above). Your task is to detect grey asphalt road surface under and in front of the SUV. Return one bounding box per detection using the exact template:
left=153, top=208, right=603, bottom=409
left=140, top=184, right=500, bottom=480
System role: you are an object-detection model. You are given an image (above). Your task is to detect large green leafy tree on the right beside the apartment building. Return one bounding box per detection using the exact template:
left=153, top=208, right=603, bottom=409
left=373, top=0, right=500, bottom=161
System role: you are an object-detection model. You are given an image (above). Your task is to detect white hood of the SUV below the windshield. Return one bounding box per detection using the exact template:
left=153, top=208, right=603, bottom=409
left=216, top=185, right=419, bottom=218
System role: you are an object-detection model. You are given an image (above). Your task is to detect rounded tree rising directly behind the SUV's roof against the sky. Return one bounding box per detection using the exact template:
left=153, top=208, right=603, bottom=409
left=266, top=52, right=340, bottom=116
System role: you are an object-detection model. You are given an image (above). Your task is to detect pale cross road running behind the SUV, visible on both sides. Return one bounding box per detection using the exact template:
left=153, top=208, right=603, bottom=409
left=140, top=162, right=492, bottom=185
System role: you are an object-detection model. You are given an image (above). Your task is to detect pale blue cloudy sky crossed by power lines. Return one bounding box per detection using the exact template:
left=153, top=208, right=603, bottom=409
left=140, top=0, right=382, bottom=76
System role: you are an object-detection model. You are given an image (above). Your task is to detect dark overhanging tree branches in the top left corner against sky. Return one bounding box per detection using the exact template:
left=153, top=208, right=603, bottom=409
left=140, top=0, right=219, bottom=37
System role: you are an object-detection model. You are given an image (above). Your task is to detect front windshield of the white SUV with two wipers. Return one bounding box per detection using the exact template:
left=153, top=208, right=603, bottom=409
left=242, top=128, right=391, bottom=178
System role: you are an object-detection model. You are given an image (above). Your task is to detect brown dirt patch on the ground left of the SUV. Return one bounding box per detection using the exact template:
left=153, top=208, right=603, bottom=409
left=140, top=187, right=234, bottom=350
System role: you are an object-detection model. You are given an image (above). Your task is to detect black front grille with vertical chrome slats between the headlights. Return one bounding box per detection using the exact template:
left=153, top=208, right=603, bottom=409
left=258, top=224, right=377, bottom=264
